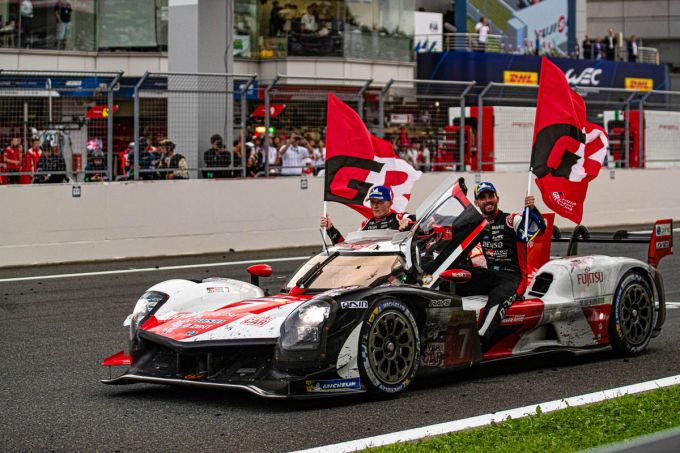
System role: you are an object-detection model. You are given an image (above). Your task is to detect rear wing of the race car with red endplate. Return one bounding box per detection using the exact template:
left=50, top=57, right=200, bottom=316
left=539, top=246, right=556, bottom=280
left=552, top=219, right=673, bottom=267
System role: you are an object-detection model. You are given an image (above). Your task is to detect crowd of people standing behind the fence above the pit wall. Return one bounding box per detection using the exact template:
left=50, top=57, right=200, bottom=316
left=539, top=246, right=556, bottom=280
left=0, top=128, right=452, bottom=185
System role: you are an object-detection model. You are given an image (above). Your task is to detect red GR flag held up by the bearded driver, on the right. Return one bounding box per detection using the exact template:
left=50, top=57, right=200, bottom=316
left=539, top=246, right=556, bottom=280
left=531, top=57, right=609, bottom=223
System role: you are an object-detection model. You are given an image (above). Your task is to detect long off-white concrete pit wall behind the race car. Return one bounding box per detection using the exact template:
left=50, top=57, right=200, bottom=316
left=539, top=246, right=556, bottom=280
left=0, top=168, right=680, bottom=267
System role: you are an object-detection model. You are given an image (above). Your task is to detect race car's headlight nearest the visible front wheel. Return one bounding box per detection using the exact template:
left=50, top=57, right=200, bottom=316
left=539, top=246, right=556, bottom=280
left=280, top=299, right=333, bottom=350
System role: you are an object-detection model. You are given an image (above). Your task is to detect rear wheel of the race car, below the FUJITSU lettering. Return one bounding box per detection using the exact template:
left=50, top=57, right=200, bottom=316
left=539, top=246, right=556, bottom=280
left=609, top=271, right=656, bottom=356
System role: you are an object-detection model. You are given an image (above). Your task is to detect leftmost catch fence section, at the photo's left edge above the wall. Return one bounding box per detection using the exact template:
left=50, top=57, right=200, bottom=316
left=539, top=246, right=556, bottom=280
left=0, top=71, right=122, bottom=184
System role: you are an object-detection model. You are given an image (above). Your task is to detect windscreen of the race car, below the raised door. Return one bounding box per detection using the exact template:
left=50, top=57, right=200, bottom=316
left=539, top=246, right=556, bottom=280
left=286, top=254, right=403, bottom=289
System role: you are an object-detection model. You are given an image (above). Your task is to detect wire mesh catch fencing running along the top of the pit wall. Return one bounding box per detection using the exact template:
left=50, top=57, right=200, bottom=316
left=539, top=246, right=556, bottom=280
left=0, top=71, right=680, bottom=183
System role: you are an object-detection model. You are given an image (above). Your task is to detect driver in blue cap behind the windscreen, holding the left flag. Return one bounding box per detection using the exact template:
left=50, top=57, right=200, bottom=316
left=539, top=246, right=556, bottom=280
left=321, top=186, right=409, bottom=244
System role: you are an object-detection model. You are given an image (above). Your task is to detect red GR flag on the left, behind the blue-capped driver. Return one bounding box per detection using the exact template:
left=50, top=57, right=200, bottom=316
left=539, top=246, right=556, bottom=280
left=324, top=93, right=422, bottom=217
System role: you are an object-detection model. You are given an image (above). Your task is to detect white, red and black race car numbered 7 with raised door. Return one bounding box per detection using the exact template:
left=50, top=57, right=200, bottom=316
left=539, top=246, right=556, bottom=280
left=102, top=179, right=673, bottom=398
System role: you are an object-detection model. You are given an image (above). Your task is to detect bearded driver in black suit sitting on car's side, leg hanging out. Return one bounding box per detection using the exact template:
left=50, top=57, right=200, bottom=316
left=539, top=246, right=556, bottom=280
left=458, top=182, right=545, bottom=352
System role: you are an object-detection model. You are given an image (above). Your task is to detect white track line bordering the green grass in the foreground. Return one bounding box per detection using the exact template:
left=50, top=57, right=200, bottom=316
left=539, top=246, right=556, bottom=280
left=296, top=375, right=680, bottom=453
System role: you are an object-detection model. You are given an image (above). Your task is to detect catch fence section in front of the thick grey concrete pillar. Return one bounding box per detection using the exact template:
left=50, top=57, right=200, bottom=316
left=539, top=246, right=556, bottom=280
left=131, top=73, right=256, bottom=180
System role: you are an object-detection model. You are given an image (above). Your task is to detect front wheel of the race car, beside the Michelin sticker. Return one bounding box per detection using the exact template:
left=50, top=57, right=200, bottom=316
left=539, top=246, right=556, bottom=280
left=358, top=299, right=420, bottom=399
